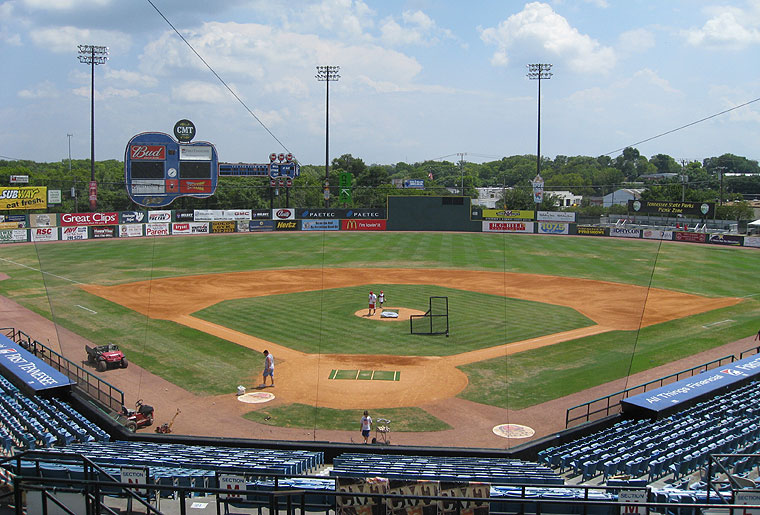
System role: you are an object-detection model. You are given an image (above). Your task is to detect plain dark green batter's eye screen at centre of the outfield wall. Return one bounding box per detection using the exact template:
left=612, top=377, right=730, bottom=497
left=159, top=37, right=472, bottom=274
left=387, top=196, right=482, bottom=232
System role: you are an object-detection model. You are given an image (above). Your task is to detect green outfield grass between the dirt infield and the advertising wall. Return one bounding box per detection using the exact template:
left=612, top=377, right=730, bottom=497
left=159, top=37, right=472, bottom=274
left=0, top=232, right=760, bottom=406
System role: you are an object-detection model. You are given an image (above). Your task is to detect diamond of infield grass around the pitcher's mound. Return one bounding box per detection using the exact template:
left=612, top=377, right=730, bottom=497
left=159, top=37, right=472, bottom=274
left=193, top=284, right=594, bottom=356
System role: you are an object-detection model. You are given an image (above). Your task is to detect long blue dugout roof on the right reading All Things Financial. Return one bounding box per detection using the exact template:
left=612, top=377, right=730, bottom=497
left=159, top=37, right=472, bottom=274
left=620, top=354, right=760, bottom=415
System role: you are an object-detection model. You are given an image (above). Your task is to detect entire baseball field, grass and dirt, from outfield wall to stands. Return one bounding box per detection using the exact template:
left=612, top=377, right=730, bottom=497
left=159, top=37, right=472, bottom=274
left=0, top=232, right=760, bottom=447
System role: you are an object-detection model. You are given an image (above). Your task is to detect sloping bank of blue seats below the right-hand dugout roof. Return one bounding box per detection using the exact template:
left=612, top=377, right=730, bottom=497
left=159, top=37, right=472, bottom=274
left=539, top=382, right=760, bottom=481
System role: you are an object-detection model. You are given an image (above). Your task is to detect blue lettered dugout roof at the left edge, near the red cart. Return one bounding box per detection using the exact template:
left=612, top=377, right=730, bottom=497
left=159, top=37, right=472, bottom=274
left=0, top=335, right=75, bottom=391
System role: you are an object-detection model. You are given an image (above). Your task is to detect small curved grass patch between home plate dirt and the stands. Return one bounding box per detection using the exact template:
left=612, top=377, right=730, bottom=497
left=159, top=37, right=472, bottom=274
left=244, top=403, right=451, bottom=432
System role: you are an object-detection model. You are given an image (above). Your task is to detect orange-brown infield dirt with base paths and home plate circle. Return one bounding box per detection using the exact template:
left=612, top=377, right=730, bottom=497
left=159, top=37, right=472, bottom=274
left=82, top=268, right=740, bottom=420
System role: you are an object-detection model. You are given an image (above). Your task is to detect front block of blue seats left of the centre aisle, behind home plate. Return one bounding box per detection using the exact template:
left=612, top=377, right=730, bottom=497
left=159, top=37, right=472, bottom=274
left=56, top=441, right=324, bottom=475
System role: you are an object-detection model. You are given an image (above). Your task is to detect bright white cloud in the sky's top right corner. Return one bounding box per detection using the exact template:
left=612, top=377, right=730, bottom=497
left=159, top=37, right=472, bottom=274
left=681, top=2, right=760, bottom=49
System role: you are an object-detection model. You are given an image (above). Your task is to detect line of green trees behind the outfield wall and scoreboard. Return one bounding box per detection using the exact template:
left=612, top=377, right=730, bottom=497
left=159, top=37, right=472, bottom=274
left=0, top=147, right=760, bottom=220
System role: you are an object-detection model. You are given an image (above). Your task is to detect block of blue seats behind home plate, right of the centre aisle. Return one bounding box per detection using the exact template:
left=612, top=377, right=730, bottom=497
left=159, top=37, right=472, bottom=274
left=330, top=453, right=564, bottom=485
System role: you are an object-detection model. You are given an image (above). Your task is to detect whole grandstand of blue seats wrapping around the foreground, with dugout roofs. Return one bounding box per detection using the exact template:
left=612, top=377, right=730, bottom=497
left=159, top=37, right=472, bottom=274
left=0, top=324, right=760, bottom=513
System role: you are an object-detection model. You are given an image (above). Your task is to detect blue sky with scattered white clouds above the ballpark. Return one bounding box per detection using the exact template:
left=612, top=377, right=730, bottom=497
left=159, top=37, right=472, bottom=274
left=0, top=0, right=760, bottom=164
